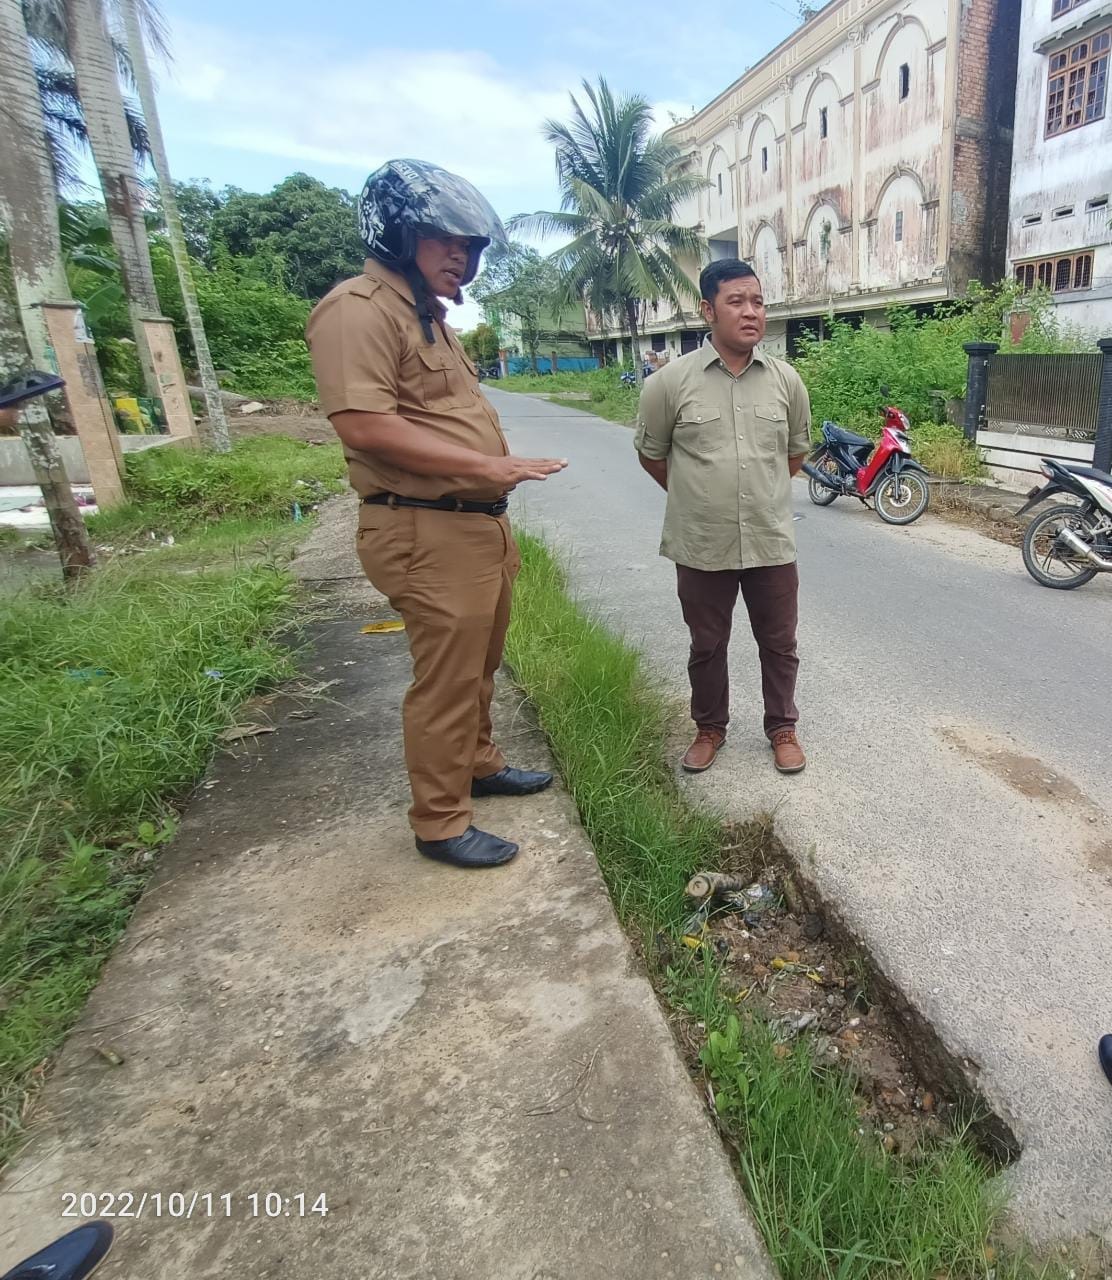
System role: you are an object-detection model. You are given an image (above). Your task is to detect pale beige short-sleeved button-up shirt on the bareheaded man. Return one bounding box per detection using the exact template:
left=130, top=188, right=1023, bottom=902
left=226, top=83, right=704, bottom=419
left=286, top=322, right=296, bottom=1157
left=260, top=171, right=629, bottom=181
left=635, top=340, right=811, bottom=570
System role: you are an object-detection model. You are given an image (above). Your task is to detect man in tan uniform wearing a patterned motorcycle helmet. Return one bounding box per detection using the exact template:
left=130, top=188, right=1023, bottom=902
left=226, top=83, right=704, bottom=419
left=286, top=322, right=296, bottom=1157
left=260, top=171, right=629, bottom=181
left=306, top=160, right=567, bottom=867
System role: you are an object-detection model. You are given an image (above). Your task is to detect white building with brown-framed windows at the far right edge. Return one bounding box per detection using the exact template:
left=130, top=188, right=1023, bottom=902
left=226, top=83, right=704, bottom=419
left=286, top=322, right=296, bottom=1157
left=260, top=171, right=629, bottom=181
left=1008, top=0, right=1112, bottom=337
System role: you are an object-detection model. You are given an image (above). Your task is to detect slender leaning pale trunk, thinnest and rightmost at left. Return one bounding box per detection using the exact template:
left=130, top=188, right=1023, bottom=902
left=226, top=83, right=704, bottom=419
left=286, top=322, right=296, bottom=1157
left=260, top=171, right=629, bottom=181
left=120, top=0, right=232, bottom=453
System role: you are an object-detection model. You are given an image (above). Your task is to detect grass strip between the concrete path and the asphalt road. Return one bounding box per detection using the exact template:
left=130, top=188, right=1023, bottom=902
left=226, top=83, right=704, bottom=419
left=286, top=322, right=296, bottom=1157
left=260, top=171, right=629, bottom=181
left=507, top=536, right=1056, bottom=1280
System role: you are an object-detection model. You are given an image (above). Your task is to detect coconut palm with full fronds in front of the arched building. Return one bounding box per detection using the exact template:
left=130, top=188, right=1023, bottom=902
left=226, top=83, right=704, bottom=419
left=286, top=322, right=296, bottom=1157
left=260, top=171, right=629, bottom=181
left=511, top=78, right=706, bottom=381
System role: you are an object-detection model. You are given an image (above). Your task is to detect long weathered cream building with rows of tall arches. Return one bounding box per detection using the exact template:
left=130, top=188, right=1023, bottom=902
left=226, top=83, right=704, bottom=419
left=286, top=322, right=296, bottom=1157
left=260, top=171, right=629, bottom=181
left=598, top=0, right=1018, bottom=352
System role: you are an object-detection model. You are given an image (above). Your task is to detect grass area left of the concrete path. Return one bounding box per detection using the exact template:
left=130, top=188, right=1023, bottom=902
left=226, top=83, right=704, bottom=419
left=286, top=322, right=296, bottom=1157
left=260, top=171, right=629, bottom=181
left=0, top=438, right=338, bottom=1165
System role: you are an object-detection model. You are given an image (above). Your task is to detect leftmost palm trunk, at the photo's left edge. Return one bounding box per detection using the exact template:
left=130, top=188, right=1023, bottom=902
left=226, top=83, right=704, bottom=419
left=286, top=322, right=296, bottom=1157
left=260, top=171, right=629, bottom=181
left=0, top=0, right=96, bottom=577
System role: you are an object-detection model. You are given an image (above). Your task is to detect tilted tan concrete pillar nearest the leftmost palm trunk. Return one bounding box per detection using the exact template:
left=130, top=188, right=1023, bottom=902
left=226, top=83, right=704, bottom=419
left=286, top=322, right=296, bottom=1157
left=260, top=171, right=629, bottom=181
left=42, top=302, right=124, bottom=508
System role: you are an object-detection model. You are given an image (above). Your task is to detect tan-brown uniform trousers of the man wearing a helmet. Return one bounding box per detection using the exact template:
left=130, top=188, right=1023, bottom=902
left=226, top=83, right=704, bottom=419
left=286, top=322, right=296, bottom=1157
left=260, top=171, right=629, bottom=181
left=356, top=506, right=521, bottom=840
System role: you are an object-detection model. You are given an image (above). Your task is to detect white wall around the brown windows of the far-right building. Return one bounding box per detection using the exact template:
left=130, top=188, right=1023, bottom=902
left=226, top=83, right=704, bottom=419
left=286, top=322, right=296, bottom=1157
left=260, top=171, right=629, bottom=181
left=1008, top=0, right=1112, bottom=337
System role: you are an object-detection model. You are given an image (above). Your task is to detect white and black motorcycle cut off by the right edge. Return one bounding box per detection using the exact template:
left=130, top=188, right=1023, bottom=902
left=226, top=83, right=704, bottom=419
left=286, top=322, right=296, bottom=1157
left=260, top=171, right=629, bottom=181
left=1016, top=458, right=1112, bottom=591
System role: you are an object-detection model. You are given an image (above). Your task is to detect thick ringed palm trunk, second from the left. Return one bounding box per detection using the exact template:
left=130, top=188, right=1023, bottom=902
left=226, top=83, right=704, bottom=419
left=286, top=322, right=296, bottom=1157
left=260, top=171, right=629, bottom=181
left=65, top=0, right=161, bottom=397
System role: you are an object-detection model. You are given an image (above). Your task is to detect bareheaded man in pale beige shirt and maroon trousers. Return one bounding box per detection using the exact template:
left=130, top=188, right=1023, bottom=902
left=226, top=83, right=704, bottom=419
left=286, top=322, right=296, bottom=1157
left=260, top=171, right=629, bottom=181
left=635, top=259, right=811, bottom=773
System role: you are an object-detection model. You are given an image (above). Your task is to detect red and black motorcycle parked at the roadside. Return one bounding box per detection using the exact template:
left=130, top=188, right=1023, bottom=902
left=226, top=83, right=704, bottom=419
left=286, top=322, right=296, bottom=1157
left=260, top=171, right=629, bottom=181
left=804, top=388, right=930, bottom=525
